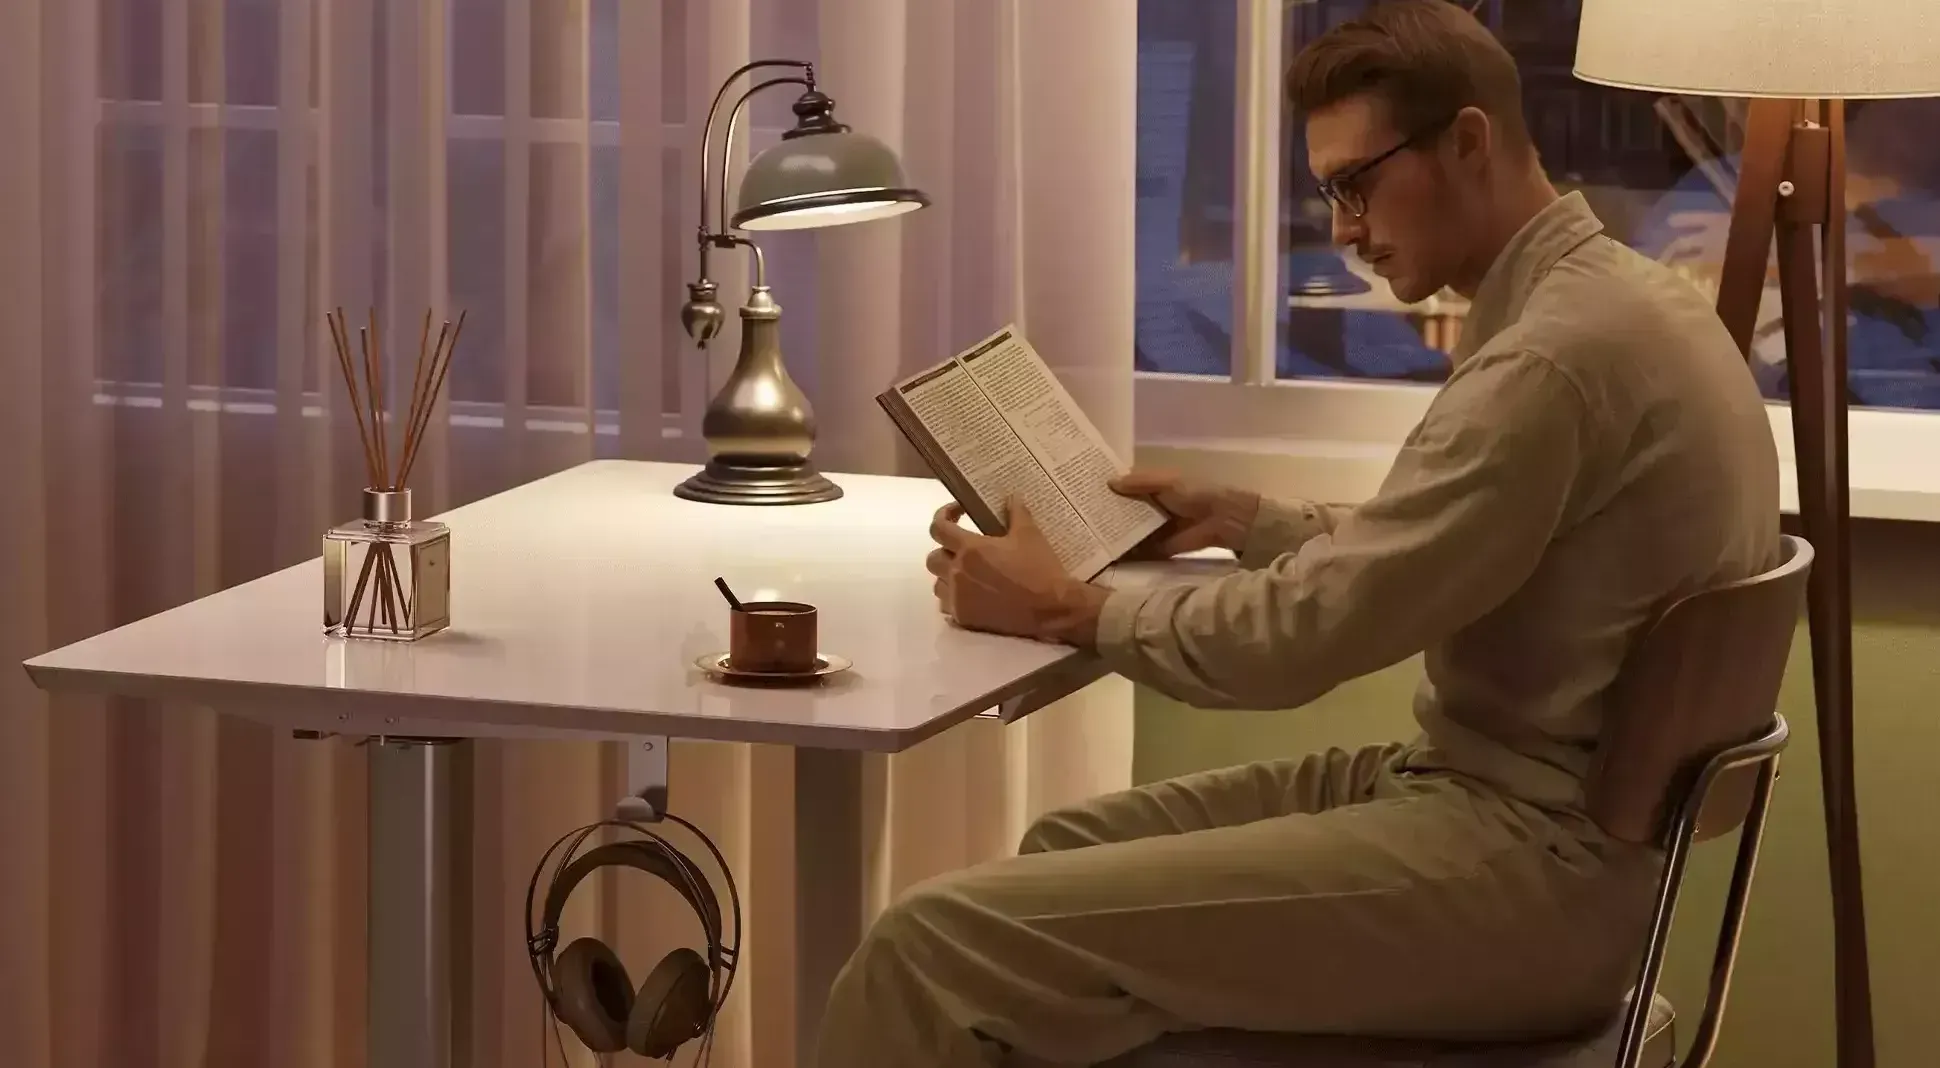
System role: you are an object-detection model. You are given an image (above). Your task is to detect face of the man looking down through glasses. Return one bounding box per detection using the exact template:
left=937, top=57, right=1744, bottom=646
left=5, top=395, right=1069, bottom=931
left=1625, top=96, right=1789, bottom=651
left=1308, top=95, right=1467, bottom=304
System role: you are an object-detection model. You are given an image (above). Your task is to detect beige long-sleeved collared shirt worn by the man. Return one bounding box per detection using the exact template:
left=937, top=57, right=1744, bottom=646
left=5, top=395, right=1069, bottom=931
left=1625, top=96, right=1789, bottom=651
left=1098, top=194, right=1779, bottom=808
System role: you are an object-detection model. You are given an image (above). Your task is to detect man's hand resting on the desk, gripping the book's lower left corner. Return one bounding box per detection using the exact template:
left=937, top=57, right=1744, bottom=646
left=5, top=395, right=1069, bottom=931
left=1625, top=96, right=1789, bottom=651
left=925, top=500, right=1106, bottom=645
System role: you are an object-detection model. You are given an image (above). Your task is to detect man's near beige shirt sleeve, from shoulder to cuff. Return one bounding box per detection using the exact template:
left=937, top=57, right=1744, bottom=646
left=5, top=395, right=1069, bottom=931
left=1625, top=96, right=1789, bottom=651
left=1098, top=353, right=1593, bottom=709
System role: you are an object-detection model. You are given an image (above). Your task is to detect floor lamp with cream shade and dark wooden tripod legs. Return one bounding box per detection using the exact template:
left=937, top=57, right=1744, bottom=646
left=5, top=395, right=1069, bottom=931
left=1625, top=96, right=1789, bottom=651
left=1575, top=0, right=1940, bottom=1068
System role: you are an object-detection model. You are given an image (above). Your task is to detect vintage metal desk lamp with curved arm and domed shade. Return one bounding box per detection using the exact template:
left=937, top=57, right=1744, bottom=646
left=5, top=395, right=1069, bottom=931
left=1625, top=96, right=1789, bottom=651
left=673, top=60, right=929, bottom=504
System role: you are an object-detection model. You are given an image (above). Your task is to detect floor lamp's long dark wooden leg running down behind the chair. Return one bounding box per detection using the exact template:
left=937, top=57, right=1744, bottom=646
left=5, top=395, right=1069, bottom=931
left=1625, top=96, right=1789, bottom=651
left=1775, top=110, right=1874, bottom=1068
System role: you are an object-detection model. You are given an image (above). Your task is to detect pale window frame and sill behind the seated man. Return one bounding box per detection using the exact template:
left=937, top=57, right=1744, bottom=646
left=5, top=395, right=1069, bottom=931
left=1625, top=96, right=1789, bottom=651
left=1133, top=0, right=1940, bottom=521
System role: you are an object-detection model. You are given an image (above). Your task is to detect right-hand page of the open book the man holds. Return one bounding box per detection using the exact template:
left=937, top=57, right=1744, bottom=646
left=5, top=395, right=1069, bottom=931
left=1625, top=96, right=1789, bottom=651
left=962, top=330, right=1166, bottom=560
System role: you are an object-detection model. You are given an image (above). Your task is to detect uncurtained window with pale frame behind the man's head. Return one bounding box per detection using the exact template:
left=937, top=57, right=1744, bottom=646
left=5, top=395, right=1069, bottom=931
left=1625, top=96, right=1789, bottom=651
left=1135, top=0, right=1940, bottom=508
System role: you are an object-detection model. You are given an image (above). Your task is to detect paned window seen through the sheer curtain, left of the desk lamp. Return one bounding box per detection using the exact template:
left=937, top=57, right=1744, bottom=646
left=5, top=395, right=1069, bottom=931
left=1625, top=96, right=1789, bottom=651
left=95, top=0, right=817, bottom=444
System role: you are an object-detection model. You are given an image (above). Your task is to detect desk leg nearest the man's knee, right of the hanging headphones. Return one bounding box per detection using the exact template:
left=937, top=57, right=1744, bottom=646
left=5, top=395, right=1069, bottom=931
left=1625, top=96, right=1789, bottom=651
left=799, top=748, right=863, bottom=1068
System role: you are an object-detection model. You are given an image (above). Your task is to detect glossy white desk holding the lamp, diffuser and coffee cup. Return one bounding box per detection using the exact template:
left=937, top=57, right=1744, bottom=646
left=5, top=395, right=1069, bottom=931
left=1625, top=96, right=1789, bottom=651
left=27, top=461, right=1164, bottom=1068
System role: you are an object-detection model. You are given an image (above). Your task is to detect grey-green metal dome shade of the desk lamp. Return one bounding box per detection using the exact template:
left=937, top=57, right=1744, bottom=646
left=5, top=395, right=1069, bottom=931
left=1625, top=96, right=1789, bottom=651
left=733, top=126, right=929, bottom=231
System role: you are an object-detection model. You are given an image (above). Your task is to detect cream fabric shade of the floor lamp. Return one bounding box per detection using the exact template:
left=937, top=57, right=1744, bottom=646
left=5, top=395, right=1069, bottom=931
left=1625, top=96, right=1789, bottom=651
left=1575, top=0, right=1940, bottom=99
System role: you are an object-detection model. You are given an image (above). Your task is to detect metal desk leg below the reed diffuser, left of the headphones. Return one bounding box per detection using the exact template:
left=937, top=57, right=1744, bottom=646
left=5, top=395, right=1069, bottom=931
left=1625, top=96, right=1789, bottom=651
left=367, top=738, right=458, bottom=1068
